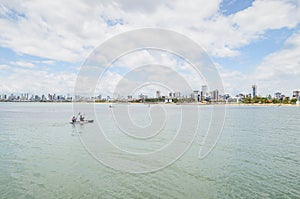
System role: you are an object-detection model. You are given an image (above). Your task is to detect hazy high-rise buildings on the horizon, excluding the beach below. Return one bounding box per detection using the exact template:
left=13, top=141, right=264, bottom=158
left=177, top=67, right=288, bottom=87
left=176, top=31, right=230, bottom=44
left=0, top=84, right=300, bottom=102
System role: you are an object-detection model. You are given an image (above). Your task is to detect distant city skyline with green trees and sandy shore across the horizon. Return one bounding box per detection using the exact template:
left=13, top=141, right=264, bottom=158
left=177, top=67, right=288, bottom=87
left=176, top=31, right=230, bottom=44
left=0, top=85, right=300, bottom=104
